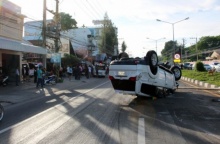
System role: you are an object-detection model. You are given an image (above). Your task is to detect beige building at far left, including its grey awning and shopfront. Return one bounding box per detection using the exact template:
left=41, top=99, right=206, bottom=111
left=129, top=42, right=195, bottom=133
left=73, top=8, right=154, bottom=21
left=0, top=0, right=46, bottom=81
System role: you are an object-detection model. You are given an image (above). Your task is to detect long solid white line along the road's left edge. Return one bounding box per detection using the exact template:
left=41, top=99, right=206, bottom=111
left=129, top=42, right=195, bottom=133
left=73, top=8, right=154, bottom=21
left=0, top=81, right=109, bottom=134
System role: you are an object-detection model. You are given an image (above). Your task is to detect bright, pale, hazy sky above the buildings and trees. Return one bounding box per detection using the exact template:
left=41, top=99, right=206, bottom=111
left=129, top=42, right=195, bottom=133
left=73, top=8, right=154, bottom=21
left=10, top=0, right=220, bottom=57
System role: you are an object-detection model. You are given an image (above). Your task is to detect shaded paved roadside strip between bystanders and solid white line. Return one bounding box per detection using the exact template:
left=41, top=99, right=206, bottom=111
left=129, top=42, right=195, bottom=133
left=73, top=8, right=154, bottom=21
left=0, top=76, right=96, bottom=106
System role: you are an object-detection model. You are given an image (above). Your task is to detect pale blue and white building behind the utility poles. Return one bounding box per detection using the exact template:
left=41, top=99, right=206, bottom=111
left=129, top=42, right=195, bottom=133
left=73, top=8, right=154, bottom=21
left=24, top=20, right=100, bottom=63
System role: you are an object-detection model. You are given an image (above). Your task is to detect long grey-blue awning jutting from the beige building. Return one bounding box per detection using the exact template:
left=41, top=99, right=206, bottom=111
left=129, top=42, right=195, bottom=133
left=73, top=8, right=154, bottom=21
left=0, top=37, right=47, bottom=54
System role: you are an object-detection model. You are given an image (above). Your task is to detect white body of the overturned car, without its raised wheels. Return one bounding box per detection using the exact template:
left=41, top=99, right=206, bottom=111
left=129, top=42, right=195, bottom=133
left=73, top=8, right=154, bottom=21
left=109, top=51, right=180, bottom=97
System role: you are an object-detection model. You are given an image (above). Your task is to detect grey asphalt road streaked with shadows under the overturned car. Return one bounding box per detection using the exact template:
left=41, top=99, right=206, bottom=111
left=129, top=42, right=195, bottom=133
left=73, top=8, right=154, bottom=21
left=0, top=78, right=220, bottom=144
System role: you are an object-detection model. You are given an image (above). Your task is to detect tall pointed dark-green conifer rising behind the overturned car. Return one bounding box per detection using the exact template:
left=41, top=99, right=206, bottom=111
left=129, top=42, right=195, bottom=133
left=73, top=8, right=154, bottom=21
left=99, top=13, right=118, bottom=56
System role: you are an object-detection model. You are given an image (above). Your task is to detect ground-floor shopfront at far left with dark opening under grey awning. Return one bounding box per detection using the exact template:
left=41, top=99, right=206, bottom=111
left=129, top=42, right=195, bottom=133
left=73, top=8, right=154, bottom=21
left=0, top=37, right=47, bottom=81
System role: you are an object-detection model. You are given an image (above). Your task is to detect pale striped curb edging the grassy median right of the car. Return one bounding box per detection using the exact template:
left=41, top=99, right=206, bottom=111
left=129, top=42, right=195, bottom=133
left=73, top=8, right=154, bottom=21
left=181, top=76, right=220, bottom=90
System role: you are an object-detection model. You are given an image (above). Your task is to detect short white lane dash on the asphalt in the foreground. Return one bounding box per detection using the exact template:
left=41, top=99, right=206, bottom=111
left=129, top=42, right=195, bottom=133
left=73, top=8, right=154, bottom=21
left=137, top=118, right=145, bottom=144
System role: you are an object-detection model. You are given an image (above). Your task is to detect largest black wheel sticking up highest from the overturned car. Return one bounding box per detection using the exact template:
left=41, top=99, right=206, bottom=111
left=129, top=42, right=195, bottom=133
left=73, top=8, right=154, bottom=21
left=145, top=50, right=158, bottom=75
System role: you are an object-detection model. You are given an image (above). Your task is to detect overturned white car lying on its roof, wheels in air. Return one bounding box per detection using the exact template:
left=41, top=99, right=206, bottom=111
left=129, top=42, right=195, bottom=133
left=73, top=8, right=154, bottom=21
left=109, top=50, right=182, bottom=97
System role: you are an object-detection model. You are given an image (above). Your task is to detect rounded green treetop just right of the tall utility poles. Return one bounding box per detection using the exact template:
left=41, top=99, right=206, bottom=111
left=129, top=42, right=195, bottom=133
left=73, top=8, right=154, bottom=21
left=59, top=12, right=77, bottom=31
